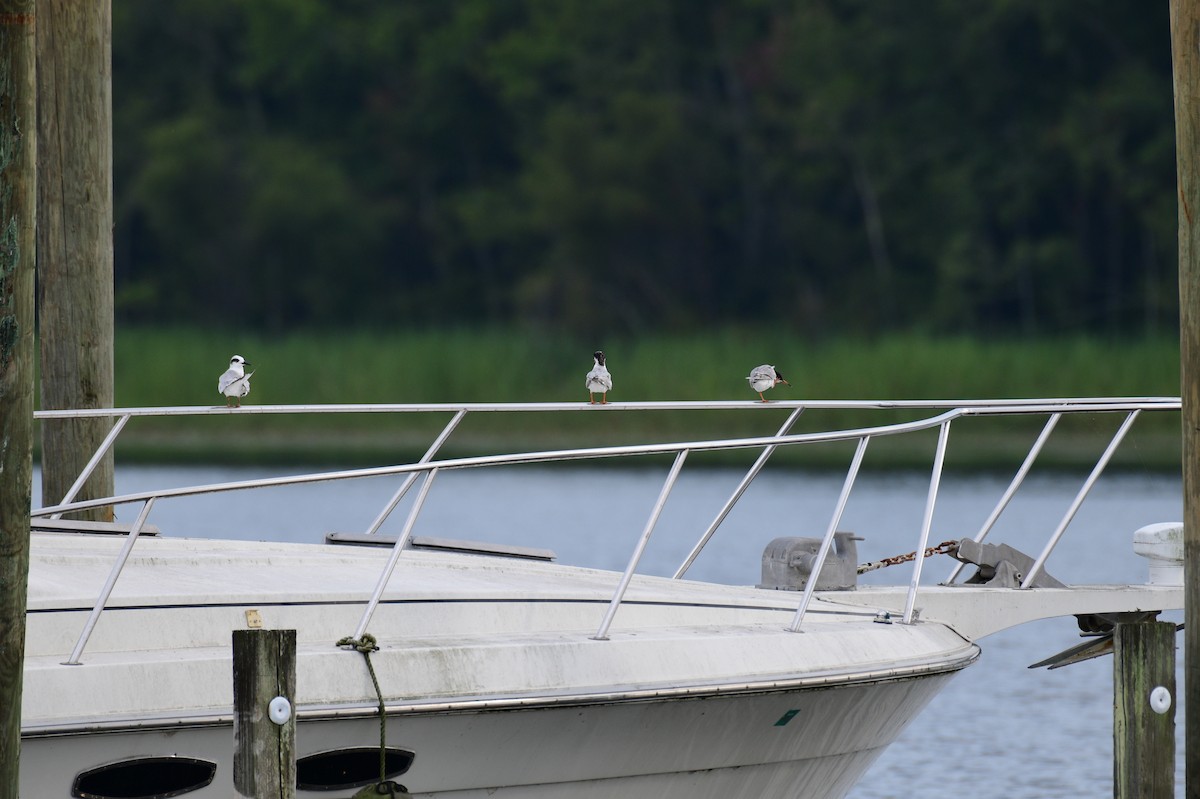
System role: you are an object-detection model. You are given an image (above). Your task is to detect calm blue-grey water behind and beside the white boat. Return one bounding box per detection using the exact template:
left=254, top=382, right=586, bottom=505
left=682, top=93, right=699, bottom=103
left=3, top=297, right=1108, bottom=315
left=35, top=464, right=1183, bottom=799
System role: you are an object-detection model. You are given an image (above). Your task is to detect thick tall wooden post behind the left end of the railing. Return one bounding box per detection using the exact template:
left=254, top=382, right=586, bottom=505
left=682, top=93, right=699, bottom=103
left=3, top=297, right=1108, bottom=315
left=37, top=0, right=113, bottom=522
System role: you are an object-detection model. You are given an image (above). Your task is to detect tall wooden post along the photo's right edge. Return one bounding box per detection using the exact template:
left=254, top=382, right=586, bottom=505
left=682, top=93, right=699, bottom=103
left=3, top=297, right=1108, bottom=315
left=1170, top=0, right=1200, bottom=799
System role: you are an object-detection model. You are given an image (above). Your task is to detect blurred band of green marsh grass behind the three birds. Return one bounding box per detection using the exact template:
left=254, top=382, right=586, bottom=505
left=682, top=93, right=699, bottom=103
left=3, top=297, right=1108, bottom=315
left=88, top=328, right=1178, bottom=468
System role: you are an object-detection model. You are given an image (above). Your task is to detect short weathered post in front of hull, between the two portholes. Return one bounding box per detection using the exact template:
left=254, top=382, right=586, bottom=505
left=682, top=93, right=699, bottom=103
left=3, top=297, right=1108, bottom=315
left=233, top=630, right=296, bottom=799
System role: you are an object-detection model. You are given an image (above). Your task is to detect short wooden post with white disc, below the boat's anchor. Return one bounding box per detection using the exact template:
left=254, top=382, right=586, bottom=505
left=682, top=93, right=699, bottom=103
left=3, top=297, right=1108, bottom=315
left=1112, top=621, right=1176, bottom=799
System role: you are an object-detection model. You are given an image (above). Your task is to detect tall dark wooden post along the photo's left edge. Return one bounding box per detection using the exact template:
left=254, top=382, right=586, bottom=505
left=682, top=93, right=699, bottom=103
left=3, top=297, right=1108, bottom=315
left=0, top=0, right=37, bottom=797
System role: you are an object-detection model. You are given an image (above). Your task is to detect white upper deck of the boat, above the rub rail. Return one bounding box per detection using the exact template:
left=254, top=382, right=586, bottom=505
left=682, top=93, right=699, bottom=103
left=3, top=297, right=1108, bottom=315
left=25, top=534, right=978, bottom=733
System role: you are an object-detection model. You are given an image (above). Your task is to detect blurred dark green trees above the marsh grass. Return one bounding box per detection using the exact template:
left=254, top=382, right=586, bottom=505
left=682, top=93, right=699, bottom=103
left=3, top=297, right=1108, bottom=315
left=114, top=0, right=1176, bottom=334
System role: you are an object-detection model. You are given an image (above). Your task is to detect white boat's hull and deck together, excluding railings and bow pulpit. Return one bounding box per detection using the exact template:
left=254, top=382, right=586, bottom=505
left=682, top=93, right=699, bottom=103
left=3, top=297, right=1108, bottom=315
left=22, top=534, right=978, bottom=799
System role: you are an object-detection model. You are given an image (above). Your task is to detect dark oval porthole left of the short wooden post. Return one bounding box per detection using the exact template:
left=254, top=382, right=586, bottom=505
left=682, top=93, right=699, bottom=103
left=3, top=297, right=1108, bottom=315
left=71, top=757, right=217, bottom=799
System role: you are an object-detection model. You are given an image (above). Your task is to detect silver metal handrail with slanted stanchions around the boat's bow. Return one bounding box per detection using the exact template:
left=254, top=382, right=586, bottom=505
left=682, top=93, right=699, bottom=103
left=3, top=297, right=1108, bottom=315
left=31, top=397, right=1181, bottom=665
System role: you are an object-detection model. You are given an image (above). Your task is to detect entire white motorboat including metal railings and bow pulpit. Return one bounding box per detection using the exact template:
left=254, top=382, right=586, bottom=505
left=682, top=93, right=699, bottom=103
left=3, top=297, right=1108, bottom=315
left=20, top=398, right=1183, bottom=799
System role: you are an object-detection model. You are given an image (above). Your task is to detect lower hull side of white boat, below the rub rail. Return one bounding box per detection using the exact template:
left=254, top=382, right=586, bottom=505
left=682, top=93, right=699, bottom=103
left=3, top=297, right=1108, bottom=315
left=20, top=661, right=970, bottom=799
